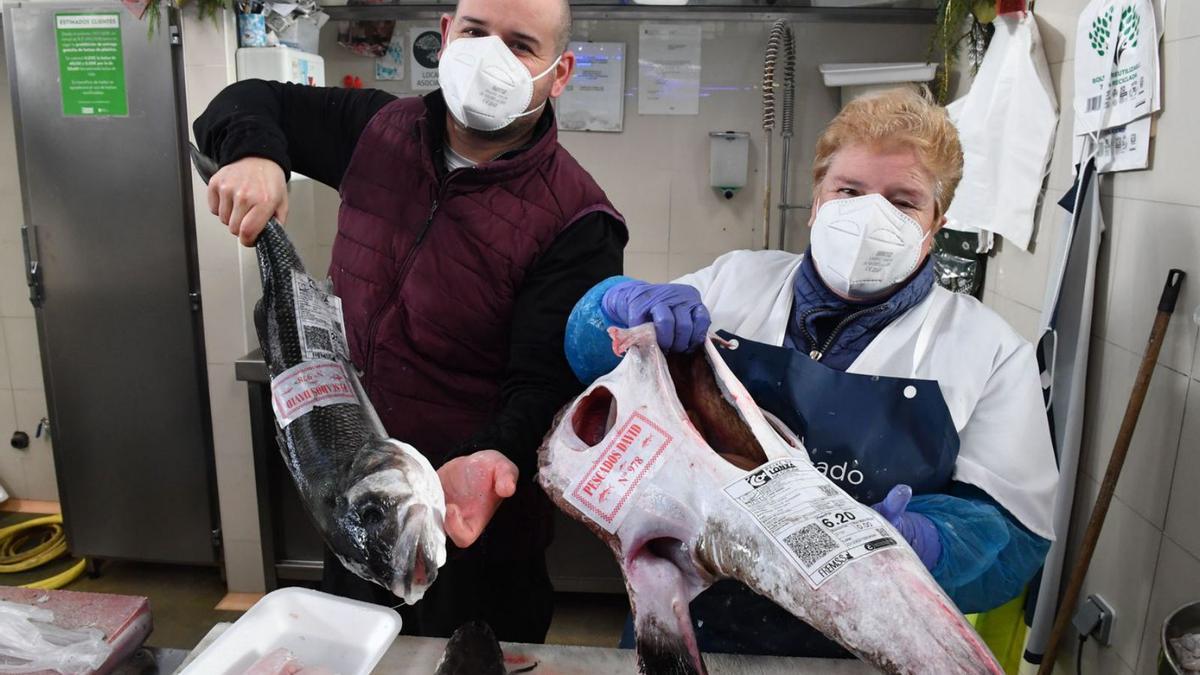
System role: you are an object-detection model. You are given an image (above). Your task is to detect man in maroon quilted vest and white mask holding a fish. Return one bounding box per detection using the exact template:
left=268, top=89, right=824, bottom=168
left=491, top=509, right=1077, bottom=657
left=194, top=0, right=628, bottom=643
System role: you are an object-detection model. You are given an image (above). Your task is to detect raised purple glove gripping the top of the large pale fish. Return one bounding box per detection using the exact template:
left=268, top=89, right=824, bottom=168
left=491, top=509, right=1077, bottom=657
left=600, top=280, right=713, bottom=352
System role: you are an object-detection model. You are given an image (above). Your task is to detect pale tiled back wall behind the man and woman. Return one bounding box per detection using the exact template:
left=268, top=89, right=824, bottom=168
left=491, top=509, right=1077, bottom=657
left=310, top=20, right=929, bottom=281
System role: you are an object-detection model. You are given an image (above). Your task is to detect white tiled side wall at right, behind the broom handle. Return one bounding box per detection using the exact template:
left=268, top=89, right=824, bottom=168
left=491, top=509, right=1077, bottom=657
left=985, top=0, right=1200, bottom=674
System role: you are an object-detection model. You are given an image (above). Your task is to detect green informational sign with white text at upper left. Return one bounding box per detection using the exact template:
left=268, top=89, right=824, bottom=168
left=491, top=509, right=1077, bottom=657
left=54, top=12, right=128, bottom=117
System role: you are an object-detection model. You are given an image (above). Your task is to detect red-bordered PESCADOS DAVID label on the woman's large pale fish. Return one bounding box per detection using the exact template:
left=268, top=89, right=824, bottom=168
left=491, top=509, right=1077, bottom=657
left=568, top=412, right=673, bottom=532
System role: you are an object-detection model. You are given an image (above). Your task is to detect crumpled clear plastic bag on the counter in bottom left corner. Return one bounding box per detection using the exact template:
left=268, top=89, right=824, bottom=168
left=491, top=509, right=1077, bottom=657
left=0, top=601, right=113, bottom=675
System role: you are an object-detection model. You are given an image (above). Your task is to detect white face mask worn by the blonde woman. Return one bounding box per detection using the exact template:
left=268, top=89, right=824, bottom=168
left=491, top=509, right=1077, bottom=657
left=811, top=195, right=929, bottom=298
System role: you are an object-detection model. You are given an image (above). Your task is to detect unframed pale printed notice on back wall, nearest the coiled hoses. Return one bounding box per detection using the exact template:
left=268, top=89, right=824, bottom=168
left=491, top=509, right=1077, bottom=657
left=637, top=23, right=701, bottom=115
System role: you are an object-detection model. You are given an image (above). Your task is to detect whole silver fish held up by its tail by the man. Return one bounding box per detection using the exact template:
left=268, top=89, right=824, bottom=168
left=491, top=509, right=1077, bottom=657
left=192, top=147, right=446, bottom=603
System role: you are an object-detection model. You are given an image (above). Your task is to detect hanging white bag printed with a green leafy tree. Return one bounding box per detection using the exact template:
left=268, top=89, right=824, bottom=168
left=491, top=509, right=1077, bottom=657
left=1074, top=0, right=1162, bottom=135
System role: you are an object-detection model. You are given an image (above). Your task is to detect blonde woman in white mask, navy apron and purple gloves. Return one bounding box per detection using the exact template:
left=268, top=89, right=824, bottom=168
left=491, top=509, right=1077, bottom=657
left=566, top=89, right=1057, bottom=656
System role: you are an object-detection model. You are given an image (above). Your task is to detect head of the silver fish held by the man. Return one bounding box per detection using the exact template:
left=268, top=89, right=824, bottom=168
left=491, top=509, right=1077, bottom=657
left=334, top=438, right=446, bottom=604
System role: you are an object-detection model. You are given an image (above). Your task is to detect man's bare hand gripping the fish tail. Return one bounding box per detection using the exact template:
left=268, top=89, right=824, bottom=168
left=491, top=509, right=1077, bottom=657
left=209, top=157, right=288, bottom=246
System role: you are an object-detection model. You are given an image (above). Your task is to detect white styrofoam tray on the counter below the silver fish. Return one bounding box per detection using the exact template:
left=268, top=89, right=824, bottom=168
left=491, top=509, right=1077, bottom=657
left=181, top=589, right=400, bottom=675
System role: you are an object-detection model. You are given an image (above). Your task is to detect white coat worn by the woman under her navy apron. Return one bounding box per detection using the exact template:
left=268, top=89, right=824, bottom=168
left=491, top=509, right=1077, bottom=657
left=677, top=251, right=1058, bottom=539
